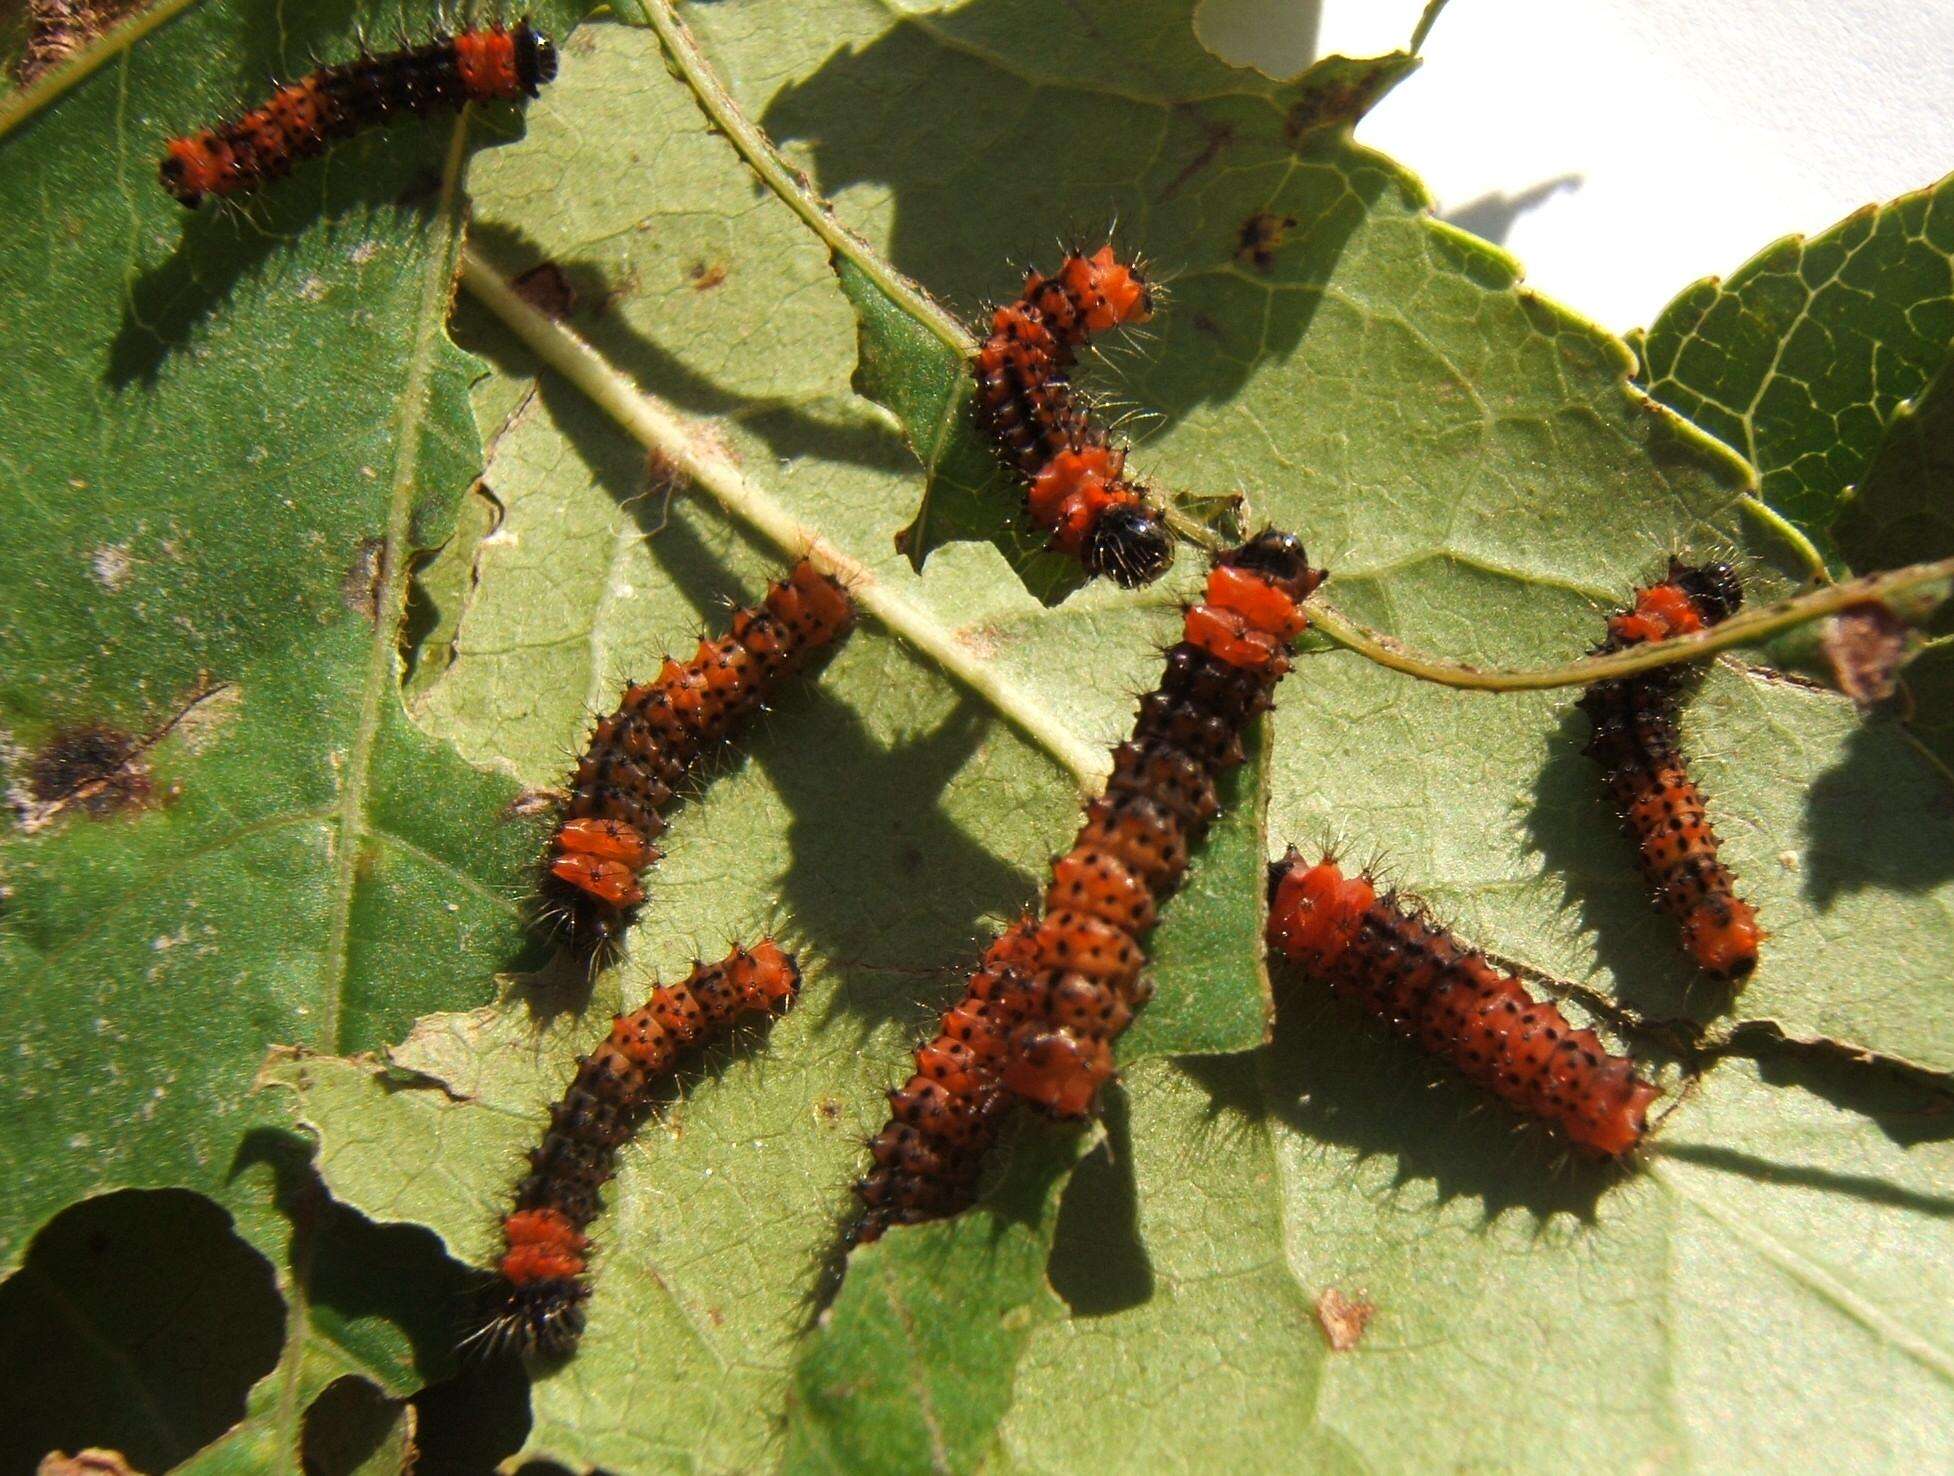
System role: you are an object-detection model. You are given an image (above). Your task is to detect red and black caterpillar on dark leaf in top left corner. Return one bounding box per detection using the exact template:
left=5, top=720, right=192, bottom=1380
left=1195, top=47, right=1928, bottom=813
left=158, top=20, right=557, bottom=209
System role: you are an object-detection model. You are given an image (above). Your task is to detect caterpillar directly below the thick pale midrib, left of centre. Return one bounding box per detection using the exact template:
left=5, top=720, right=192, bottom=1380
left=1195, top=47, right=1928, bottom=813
left=543, top=559, right=854, bottom=964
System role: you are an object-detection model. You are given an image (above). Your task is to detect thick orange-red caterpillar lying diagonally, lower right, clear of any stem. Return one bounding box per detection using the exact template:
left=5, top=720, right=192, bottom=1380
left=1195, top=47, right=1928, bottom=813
left=1268, top=848, right=1661, bottom=1157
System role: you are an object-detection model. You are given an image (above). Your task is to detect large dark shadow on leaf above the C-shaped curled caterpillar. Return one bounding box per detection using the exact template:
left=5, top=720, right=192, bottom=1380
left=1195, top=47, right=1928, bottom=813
left=762, top=0, right=1375, bottom=432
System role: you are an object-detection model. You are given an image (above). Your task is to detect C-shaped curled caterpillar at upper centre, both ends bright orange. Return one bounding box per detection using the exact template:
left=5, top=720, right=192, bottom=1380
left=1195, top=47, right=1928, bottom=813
left=975, top=246, right=1174, bottom=586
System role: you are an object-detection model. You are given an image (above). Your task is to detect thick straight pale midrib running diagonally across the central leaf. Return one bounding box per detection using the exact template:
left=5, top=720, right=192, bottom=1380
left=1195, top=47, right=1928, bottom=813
left=447, top=250, right=1108, bottom=790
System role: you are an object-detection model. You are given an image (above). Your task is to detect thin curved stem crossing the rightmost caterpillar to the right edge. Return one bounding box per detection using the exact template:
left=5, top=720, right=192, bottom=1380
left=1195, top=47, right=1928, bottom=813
left=1309, top=559, right=1954, bottom=692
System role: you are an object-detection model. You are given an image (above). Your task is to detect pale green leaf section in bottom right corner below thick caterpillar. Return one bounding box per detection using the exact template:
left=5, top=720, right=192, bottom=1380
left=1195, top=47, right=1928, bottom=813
left=993, top=1024, right=1954, bottom=1470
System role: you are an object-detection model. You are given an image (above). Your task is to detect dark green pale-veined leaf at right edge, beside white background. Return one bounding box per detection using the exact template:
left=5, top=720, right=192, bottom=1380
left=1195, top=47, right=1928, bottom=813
left=1641, top=180, right=1954, bottom=559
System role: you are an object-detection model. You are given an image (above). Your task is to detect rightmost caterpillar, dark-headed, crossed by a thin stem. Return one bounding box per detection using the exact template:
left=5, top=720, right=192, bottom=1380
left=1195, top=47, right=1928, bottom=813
left=1581, top=559, right=1763, bottom=979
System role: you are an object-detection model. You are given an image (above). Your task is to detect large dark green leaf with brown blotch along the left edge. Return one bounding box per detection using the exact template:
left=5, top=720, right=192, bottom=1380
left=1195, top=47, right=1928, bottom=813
left=0, top=4, right=586, bottom=1470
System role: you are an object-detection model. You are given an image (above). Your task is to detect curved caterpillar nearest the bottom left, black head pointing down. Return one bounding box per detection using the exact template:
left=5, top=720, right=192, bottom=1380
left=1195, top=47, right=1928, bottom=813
left=479, top=938, right=801, bottom=1359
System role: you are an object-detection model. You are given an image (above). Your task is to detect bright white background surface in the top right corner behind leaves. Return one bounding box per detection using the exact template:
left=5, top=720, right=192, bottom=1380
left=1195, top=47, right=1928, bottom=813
left=1196, top=0, right=1954, bottom=330
